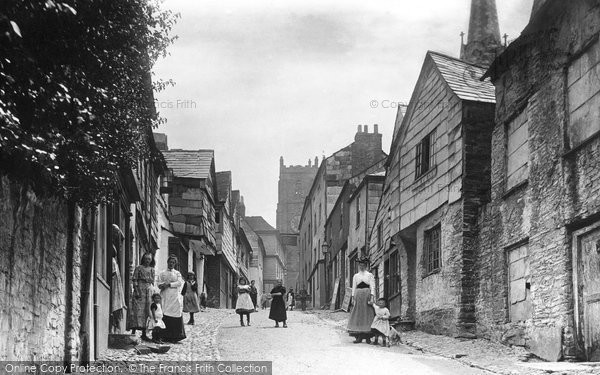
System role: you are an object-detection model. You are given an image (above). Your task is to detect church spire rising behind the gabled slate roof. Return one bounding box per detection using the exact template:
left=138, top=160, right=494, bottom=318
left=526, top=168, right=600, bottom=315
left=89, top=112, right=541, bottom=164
left=460, top=0, right=502, bottom=67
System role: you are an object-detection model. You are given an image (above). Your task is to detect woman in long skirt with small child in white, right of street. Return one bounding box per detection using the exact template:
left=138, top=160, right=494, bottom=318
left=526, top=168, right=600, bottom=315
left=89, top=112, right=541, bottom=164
left=348, top=258, right=390, bottom=346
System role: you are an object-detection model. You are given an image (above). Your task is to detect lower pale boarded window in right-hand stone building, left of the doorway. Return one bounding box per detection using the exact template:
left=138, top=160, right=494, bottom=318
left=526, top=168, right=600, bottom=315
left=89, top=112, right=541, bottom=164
left=508, top=244, right=532, bottom=322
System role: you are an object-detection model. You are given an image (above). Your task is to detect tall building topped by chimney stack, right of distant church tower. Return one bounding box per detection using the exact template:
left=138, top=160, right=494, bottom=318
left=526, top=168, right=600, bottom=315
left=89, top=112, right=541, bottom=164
left=298, top=125, right=386, bottom=306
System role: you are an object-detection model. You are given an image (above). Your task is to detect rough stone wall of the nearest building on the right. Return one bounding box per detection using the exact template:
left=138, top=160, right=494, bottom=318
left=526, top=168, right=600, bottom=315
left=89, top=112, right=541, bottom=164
left=477, top=0, right=600, bottom=360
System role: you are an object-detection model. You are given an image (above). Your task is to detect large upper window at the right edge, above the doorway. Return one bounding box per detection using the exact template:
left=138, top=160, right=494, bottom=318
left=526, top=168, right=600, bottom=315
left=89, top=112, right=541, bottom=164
left=567, top=42, right=600, bottom=149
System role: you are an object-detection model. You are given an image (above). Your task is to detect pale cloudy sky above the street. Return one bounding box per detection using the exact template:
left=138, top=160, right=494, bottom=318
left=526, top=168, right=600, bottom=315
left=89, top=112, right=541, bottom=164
left=154, top=0, right=533, bottom=226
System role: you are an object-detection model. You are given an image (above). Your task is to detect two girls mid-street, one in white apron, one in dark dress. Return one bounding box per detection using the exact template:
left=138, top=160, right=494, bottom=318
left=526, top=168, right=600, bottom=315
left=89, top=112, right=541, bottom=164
left=235, top=277, right=293, bottom=328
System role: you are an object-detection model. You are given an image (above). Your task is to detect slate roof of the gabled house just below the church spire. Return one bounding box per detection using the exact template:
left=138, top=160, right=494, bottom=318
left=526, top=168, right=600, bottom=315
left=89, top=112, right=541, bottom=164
left=428, top=51, right=496, bottom=103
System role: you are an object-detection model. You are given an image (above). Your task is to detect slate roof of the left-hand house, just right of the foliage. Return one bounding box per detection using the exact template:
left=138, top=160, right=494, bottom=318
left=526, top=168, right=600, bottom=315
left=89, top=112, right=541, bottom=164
left=163, top=150, right=215, bottom=179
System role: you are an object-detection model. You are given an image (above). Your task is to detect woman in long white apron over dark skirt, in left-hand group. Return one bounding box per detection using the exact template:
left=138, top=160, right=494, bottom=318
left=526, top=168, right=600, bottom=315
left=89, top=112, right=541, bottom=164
left=158, top=255, right=185, bottom=342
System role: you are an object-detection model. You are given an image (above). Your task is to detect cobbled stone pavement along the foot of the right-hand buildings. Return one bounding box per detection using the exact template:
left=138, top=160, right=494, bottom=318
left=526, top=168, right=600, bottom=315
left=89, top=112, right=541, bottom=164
left=306, top=310, right=600, bottom=375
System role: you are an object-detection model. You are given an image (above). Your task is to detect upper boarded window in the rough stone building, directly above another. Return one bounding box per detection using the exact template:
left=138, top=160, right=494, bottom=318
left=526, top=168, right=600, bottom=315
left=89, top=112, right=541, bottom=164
left=506, top=110, right=529, bottom=190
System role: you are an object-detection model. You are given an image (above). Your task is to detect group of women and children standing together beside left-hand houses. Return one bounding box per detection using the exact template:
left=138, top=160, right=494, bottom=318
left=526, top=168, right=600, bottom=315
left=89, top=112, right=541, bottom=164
left=127, top=253, right=206, bottom=343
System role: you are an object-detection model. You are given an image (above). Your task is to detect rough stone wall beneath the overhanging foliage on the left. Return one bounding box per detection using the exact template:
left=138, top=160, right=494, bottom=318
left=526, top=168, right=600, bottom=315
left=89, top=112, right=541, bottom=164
left=0, top=175, right=81, bottom=360
